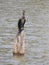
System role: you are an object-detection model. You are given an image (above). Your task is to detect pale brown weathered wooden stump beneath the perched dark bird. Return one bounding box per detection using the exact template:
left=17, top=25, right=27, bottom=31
left=13, top=31, right=25, bottom=55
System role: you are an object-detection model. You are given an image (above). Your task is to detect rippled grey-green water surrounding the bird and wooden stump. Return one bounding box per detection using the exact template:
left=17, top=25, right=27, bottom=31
left=0, top=0, right=49, bottom=65
